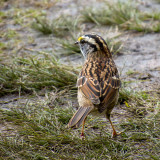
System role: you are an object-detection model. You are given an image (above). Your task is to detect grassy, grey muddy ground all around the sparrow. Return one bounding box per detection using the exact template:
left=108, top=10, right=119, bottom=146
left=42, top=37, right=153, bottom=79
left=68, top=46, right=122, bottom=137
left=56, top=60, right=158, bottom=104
left=0, top=0, right=160, bottom=160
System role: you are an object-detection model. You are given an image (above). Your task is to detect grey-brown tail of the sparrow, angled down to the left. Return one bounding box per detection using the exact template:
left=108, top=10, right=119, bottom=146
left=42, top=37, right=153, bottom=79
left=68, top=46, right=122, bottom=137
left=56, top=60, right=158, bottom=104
left=68, top=107, right=93, bottom=128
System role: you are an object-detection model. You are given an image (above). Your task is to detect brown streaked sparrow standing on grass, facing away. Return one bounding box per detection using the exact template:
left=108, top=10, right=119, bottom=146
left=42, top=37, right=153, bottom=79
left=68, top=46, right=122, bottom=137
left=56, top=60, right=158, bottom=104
left=68, top=34, right=121, bottom=137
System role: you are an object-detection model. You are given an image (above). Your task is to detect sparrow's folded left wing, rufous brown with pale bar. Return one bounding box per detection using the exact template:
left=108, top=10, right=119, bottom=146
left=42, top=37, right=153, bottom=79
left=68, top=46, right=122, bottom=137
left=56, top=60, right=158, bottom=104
left=77, top=76, right=100, bottom=104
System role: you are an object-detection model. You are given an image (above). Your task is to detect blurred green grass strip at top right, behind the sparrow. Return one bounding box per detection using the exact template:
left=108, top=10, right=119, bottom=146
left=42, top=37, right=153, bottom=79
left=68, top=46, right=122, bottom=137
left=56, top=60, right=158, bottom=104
left=82, top=1, right=160, bottom=32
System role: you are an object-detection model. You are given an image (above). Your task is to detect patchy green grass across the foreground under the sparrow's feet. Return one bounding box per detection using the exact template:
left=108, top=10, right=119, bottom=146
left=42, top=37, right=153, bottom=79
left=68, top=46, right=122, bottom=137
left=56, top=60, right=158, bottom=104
left=0, top=90, right=160, bottom=159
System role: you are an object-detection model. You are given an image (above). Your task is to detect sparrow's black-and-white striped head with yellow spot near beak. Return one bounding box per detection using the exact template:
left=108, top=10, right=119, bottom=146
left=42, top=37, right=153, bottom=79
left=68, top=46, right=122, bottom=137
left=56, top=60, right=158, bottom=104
left=75, top=34, right=111, bottom=58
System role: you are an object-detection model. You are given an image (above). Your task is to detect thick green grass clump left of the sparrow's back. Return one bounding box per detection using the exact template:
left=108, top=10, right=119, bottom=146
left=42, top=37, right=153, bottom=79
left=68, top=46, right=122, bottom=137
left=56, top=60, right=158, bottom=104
left=0, top=52, right=78, bottom=95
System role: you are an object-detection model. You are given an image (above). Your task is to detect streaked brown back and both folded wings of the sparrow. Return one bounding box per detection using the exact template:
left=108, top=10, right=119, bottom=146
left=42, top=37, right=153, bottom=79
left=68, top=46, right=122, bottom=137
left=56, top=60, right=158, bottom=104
left=77, top=58, right=121, bottom=112
